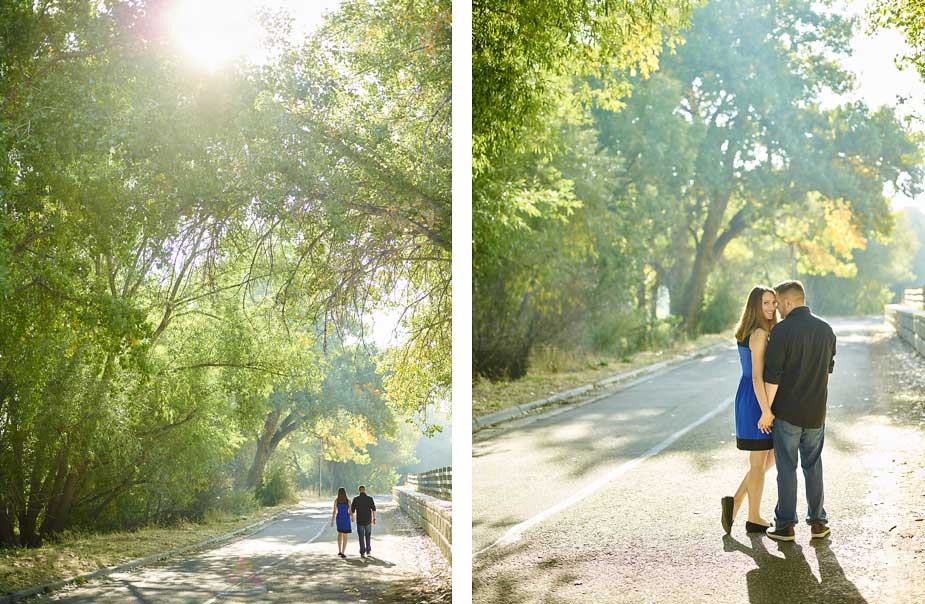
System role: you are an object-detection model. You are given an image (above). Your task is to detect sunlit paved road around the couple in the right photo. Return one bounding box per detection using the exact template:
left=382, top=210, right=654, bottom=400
left=472, top=318, right=925, bottom=604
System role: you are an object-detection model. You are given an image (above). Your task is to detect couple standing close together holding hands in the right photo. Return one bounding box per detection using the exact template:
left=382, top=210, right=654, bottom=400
left=722, top=281, right=835, bottom=541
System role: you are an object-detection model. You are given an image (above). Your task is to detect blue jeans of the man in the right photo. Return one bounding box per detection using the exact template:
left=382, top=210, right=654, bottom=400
left=773, top=418, right=828, bottom=530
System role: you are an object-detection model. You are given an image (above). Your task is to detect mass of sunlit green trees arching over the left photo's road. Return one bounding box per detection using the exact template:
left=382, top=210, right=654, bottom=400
left=0, top=1, right=449, bottom=545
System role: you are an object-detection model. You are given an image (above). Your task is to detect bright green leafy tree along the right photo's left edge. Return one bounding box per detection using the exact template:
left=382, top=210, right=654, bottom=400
left=472, top=0, right=691, bottom=377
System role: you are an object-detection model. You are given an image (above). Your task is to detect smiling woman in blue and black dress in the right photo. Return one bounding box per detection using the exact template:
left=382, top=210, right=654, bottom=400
left=722, top=285, right=777, bottom=534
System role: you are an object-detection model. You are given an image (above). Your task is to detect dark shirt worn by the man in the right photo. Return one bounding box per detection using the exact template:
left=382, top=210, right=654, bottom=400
left=764, top=306, right=835, bottom=428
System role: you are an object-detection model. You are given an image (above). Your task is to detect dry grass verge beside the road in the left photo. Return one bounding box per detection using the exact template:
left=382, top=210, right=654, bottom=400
left=0, top=496, right=324, bottom=593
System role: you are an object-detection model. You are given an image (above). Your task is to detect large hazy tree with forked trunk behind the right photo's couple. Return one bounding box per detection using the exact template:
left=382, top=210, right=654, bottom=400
left=598, top=0, right=921, bottom=331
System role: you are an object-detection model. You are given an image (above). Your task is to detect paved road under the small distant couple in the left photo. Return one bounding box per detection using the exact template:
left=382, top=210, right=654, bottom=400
left=41, top=498, right=446, bottom=604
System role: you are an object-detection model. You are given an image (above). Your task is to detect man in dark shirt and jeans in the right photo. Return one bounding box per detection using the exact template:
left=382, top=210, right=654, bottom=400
left=764, top=281, right=835, bottom=541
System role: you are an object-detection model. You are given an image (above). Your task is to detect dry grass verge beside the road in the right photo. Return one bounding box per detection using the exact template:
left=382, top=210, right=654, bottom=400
left=472, top=329, right=734, bottom=418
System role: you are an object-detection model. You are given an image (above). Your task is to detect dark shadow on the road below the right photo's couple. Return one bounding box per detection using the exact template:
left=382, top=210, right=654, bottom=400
left=723, top=535, right=867, bottom=604
